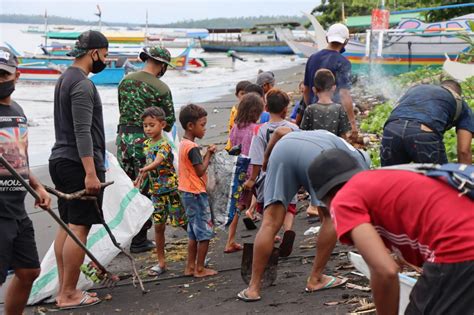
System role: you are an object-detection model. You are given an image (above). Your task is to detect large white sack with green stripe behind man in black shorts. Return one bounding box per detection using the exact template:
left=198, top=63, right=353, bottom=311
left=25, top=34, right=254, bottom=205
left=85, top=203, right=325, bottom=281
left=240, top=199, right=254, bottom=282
left=28, top=152, right=153, bottom=305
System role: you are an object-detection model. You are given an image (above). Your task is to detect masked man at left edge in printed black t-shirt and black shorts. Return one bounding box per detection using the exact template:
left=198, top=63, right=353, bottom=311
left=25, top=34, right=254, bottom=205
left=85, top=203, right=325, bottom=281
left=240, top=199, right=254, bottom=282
left=0, top=47, right=51, bottom=314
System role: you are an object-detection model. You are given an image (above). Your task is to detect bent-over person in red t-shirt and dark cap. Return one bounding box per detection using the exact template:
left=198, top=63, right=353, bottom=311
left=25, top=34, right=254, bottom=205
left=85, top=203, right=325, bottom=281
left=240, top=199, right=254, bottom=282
left=308, top=149, right=474, bottom=314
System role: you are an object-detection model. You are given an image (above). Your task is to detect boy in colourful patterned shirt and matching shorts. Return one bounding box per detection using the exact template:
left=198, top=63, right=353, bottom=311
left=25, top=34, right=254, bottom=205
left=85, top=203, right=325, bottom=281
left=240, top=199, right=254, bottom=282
left=135, top=106, right=187, bottom=276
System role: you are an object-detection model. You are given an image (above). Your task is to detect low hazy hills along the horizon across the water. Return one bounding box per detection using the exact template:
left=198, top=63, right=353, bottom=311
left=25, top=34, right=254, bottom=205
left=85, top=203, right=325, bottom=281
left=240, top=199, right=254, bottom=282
left=0, top=14, right=308, bottom=28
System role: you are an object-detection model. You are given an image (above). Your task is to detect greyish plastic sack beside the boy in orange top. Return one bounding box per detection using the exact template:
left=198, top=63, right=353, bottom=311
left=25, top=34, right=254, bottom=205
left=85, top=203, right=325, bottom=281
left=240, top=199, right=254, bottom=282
left=207, top=151, right=250, bottom=229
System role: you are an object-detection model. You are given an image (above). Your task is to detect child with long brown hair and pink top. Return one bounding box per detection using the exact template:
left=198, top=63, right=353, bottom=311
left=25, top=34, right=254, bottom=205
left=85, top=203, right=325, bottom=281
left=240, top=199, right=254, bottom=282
left=224, top=93, right=263, bottom=253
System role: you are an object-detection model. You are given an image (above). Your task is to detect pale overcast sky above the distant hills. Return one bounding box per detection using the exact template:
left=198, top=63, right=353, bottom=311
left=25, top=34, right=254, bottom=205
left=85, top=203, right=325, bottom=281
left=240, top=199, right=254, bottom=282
left=0, top=0, right=320, bottom=24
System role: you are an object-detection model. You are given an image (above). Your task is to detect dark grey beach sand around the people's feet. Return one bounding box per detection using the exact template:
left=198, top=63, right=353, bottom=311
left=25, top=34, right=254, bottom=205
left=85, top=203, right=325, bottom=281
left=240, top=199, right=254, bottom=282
left=21, top=65, right=370, bottom=314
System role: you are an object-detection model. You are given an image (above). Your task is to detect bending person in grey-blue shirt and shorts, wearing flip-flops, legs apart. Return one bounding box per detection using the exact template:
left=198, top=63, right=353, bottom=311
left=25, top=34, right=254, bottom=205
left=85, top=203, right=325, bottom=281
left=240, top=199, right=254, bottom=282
left=237, top=127, right=370, bottom=302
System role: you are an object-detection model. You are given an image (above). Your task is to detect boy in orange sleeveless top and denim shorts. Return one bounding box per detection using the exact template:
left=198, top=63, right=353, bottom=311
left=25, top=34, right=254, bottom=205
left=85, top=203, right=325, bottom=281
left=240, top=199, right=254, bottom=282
left=178, top=104, right=217, bottom=278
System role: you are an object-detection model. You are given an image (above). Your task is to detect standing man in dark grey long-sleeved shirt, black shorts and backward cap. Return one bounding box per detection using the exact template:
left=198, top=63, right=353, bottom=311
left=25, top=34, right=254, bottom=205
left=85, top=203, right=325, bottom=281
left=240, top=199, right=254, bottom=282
left=49, top=31, right=109, bottom=309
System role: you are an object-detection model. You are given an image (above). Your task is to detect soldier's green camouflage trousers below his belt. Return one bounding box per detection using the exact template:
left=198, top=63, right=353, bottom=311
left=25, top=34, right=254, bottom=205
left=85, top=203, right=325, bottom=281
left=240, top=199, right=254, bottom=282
left=115, top=133, right=146, bottom=180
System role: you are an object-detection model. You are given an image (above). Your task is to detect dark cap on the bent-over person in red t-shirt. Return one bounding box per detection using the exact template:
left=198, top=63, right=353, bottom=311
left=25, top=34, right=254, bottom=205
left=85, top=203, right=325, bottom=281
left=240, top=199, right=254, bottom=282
left=308, top=149, right=364, bottom=200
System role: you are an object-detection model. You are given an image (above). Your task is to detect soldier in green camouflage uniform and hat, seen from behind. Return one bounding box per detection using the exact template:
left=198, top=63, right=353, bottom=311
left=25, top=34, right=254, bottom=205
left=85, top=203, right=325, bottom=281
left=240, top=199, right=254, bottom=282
left=116, top=46, right=176, bottom=252
